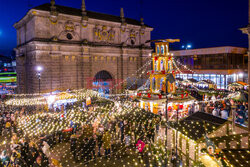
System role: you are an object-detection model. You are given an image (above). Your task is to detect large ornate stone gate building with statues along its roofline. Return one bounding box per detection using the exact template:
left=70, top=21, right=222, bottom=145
left=14, top=0, right=153, bottom=93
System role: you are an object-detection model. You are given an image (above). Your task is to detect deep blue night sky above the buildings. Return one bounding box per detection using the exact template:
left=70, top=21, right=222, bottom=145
left=0, top=0, right=248, bottom=55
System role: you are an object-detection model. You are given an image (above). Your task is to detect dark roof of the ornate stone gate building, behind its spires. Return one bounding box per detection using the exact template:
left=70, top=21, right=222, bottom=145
left=29, top=3, right=150, bottom=27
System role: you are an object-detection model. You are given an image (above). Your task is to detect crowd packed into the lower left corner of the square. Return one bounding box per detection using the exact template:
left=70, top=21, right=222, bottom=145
left=0, top=106, right=63, bottom=167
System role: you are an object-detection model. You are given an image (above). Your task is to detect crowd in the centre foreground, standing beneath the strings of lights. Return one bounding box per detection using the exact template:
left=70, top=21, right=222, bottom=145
left=70, top=105, right=160, bottom=164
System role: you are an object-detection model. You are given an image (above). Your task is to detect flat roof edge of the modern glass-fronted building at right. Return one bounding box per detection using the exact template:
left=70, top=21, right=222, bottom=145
left=171, top=46, right=247, bottom=56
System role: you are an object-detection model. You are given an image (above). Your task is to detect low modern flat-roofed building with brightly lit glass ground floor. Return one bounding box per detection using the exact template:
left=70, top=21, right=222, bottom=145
left=172, top=46, right=248, bottom=89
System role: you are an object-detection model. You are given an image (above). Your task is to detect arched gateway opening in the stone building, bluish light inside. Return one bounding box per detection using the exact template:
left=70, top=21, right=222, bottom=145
left=93, top=70, right=114, bottom=94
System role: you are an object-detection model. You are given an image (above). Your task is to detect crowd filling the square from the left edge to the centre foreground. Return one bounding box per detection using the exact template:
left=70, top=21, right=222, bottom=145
left=0, top=98, right=164, bottom=167
